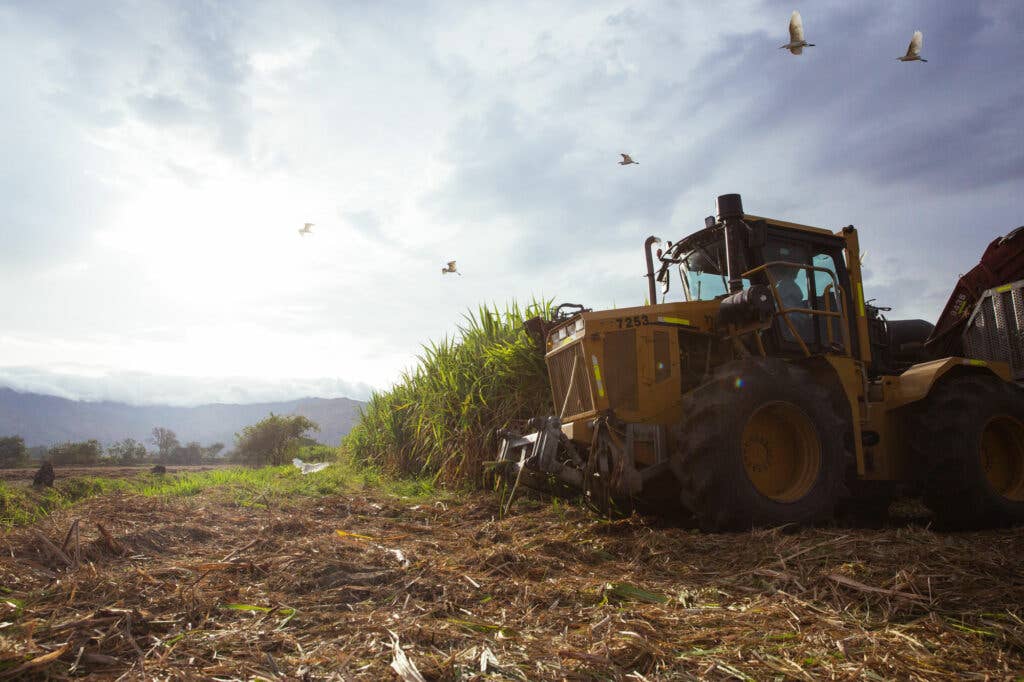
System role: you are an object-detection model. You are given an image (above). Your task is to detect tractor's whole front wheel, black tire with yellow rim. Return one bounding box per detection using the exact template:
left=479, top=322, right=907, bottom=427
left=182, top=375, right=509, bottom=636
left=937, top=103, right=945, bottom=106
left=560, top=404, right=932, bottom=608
left=672, top=359, right=847, bottom=530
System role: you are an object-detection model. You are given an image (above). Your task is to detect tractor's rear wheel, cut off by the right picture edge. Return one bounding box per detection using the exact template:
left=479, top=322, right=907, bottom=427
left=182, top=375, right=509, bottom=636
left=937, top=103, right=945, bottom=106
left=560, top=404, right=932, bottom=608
left=909, top=375, right=1024, bottom=528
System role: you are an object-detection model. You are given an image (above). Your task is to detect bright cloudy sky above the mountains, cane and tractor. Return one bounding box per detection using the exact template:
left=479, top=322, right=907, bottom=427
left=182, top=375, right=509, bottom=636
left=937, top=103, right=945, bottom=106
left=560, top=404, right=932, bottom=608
left=0, top=0, right=1024, bottom=404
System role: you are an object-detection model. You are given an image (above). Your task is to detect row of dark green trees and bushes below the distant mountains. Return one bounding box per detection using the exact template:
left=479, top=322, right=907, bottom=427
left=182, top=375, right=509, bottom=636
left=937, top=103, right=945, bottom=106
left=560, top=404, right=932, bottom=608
left=0, top=413, right=319, bottom=468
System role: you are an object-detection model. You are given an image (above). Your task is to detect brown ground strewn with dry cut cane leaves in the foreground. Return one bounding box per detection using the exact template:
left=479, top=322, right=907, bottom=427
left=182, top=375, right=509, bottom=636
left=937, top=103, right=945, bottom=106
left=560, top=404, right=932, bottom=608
left=0, top=485, right=1024, bottom=680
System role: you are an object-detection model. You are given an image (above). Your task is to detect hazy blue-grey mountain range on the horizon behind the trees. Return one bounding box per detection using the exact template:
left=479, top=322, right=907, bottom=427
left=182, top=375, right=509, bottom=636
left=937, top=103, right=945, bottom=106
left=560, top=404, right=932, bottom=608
left=0, top=387, right=366, bottom=450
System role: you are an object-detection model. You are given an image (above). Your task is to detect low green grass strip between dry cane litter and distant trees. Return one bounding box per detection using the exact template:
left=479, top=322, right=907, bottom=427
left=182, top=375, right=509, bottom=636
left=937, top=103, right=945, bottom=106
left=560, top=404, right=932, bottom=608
left=0, top=458, right=437, bottom=527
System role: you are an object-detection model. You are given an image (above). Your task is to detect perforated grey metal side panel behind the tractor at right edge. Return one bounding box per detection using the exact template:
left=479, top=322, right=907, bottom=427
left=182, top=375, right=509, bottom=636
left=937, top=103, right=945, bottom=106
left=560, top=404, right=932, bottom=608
left=964, top=282, right=1024, bottom=379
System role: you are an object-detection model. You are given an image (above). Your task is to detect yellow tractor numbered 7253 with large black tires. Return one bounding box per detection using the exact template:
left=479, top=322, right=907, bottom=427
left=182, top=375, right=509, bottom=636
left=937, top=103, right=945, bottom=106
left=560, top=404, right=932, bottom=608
left=496, top=195, right=1024, bottom=529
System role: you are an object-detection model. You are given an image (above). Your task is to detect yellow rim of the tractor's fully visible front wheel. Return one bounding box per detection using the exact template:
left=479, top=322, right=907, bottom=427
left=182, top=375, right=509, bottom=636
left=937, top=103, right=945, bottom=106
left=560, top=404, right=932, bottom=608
left=742, top=401, right=821, bottom=502
